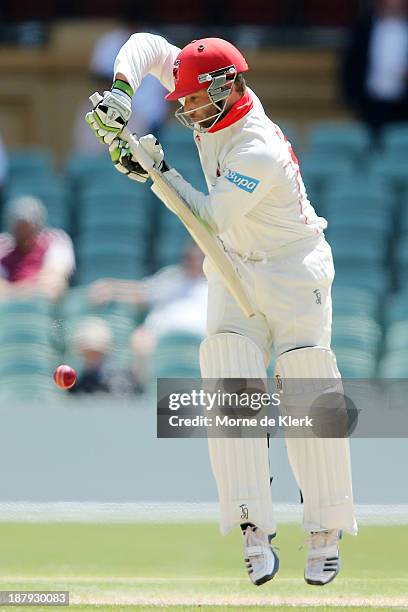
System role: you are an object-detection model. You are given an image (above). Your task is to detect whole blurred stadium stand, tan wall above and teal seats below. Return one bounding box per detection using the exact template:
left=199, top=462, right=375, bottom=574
left=0, top=0, right=408, bottom=397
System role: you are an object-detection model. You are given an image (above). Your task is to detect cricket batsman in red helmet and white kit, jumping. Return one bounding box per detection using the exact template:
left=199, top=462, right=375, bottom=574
left=87, top=33, right=357, bottom=585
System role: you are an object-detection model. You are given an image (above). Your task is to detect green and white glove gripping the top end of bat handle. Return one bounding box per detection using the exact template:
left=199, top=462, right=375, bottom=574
left=85, top=79, right=133, bottom=145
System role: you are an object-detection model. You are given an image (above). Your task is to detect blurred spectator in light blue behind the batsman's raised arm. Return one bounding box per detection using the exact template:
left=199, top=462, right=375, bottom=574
left=74, top=9, right=168, bottom=153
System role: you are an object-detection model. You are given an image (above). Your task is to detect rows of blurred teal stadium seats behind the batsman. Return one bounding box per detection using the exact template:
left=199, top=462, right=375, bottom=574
left=0, top=122, right=408, bottom=394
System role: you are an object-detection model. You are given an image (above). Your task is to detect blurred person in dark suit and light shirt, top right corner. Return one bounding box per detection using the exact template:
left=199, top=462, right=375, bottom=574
left=342, top=0, right=408, bottom=132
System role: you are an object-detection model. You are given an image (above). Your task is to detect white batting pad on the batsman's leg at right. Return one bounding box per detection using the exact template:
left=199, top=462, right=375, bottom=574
left=275, top=346, right=357, bottom=534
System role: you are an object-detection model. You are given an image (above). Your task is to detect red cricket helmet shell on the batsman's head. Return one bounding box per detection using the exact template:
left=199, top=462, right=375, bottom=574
left=166, top=38, right=248, bottom=100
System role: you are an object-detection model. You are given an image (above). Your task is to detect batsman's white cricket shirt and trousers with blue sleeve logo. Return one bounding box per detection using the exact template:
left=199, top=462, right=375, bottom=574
left=115, top=33, right=356, bottom=533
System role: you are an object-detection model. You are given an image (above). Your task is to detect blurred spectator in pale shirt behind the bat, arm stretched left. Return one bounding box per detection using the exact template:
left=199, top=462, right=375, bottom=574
left=90, top=244, right=207, bottom=386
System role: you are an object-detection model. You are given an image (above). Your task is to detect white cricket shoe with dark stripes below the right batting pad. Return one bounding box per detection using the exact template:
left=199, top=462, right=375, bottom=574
left=305, top=529, right=342, bottom=586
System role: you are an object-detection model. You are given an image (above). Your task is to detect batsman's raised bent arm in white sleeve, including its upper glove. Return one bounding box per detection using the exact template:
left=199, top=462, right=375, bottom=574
left=86, top=33, right=179, bottom=145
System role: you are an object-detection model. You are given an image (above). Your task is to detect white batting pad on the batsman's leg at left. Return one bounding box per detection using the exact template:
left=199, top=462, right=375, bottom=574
left=200, top=333, right=276, bottom=535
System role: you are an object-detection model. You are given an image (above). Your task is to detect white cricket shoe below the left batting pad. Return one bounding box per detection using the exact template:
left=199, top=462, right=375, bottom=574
left=243, top=525, right=279, bottom=586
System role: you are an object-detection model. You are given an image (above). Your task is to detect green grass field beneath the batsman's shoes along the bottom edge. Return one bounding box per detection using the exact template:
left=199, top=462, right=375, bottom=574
left=0, top=523, right=408, bottom=612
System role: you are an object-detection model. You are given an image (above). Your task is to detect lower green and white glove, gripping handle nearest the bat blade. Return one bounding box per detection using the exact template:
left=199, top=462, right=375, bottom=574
left=109, top=134, right=169, bottom=183
